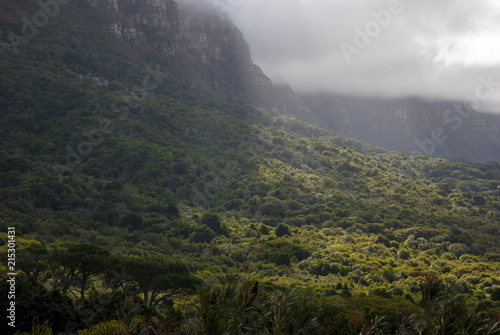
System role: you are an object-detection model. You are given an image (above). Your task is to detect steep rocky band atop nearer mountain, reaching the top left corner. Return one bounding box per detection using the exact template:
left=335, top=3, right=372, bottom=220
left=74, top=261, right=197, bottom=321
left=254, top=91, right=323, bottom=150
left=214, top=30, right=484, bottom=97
left=0, top=0, right=271, bottom=96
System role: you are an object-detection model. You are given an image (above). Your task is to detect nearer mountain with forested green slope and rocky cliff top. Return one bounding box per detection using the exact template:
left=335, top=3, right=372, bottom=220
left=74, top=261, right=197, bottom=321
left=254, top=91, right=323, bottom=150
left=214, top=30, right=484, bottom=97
left=0, top=0, right=500, bottom=334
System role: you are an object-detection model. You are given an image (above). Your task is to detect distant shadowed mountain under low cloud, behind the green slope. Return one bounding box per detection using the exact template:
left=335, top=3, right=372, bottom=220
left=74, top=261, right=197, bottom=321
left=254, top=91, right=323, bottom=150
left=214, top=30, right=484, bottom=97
left=297, top=95, right=500, bottom=163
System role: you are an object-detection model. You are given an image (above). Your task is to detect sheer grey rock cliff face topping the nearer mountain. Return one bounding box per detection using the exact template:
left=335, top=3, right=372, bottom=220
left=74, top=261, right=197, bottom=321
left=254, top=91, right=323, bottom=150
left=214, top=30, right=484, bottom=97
left=86, top=0, right=272, bottom=97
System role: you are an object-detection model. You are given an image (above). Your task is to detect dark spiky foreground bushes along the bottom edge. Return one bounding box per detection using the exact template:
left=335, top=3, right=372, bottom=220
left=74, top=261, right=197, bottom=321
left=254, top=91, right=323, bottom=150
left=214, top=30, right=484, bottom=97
left=4, top=275, right=500, bottom=335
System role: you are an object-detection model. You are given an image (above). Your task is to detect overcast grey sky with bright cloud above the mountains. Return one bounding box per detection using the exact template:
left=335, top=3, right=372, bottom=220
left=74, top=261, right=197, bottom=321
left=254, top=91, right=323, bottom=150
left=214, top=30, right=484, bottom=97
left=226, top=0, right=500, bottom=110
